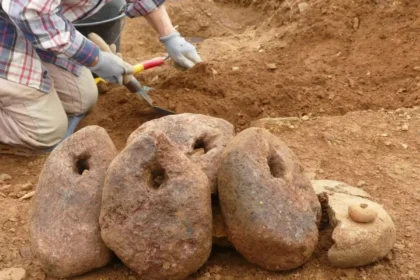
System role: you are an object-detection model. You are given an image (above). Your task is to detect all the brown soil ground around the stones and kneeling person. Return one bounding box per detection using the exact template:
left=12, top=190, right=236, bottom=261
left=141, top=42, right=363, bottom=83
left=0, top=0, right=420, bottom=280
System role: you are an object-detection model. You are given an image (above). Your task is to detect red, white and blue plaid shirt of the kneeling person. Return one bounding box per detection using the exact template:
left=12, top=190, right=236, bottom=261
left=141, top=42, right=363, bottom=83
left=0, top=0, right=165, bottom=93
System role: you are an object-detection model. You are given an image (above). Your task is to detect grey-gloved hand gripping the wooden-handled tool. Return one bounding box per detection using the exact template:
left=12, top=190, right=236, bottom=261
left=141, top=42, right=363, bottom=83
left=88, top=51, right=134, bottom=85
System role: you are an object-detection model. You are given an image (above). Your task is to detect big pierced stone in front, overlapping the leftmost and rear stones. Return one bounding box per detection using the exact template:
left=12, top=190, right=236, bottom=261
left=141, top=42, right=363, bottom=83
left=100, top=132, right=212, bottom=280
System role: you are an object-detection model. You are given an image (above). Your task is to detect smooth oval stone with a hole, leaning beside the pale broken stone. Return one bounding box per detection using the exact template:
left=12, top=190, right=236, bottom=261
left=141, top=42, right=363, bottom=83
left=218, top=128, right=321, bottom=271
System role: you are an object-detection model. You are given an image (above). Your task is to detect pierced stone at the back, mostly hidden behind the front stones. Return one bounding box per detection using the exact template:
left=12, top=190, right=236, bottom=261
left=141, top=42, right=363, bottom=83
left=127, top=114, right=235, bottom=193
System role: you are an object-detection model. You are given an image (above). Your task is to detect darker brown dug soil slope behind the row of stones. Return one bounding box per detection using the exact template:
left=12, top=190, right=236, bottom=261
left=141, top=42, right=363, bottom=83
left=85, top=0, right=420, bottom=147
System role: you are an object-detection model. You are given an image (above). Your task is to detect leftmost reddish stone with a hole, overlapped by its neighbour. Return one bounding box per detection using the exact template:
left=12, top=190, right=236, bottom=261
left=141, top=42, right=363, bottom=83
left=30, top=126, right=117, bottom=278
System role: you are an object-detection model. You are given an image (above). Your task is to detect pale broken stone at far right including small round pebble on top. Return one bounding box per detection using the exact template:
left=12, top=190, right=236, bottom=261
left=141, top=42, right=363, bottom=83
left=323, top=190, right=396, bottom=268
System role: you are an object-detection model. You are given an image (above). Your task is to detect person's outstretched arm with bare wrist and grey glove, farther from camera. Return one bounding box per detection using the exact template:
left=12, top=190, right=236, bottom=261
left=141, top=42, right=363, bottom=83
left=124, top=0, right=201, bottom=68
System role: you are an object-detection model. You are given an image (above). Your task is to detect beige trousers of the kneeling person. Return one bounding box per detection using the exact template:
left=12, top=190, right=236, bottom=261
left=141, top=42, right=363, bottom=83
left=0, top=63, right=98, bottom=149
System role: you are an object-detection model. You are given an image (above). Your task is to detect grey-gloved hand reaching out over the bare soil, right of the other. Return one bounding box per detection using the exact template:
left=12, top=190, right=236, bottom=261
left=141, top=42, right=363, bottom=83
left=160, top=32, right=202, bottom=68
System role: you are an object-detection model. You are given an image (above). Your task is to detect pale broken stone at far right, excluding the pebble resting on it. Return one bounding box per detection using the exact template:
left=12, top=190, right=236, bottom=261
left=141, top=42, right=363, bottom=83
left=312, top=180, right=396, bottom=268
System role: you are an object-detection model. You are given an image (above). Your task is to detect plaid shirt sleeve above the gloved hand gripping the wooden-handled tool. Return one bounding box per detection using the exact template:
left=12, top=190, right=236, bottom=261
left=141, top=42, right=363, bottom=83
left=2, top=0, right=99, bottom=65
